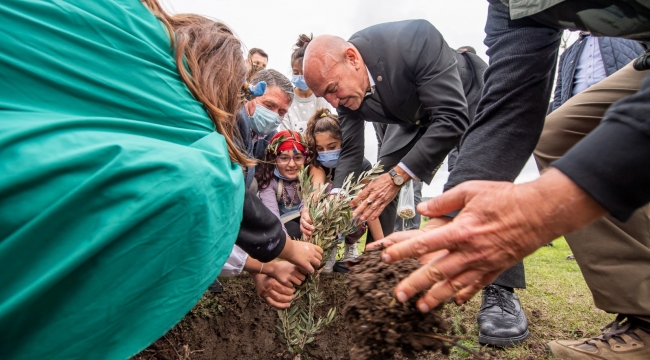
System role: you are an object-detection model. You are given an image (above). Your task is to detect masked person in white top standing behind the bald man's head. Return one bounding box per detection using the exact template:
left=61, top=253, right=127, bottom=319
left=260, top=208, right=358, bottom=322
left=280, top=34, right=329, bottom=134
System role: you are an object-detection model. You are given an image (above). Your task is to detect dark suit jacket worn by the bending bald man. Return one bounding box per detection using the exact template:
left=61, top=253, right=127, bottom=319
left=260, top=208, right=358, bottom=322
left=333, top=20, right=485, bottom=187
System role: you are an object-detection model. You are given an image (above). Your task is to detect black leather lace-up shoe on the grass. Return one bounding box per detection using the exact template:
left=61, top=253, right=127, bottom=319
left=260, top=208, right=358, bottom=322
left=478, top=285, right=530, bottom=347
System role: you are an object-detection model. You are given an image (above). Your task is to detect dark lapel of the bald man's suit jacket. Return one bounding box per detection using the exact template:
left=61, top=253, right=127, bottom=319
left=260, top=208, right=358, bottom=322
left=349, top=35, right=408, bottom=122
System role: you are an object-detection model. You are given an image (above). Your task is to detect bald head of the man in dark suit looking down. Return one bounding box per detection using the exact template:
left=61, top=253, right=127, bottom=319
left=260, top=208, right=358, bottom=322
left=303, top=35, right=370, bottom=110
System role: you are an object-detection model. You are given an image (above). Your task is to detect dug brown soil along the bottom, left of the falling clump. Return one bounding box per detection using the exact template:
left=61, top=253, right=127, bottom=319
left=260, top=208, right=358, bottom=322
left=133, top=274, right=352, bottom=360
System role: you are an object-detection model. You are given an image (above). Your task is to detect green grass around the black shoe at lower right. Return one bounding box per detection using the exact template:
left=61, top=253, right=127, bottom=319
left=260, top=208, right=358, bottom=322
left=334, top=231, right=614, bottom=359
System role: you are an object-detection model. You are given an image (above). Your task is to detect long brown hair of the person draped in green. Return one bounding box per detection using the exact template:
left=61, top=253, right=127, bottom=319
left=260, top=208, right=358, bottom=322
left=143, top=0, right=255, bottom=166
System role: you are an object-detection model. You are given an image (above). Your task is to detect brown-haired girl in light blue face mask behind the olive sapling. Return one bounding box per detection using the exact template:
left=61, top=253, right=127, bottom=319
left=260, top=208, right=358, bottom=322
left=300, top=108, right=384, bottom=273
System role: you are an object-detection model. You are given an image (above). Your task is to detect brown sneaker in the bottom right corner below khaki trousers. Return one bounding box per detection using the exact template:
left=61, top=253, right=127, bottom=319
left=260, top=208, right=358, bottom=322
left=546, top=315, right=650, bottom=360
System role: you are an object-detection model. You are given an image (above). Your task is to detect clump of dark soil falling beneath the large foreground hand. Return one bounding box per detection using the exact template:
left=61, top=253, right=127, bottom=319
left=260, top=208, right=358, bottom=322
left=344, top=250, right=453, bottom=360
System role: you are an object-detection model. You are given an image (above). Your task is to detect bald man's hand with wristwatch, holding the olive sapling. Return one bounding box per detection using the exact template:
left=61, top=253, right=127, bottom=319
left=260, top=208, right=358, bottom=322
left=350, top=166, right=411, bottom=222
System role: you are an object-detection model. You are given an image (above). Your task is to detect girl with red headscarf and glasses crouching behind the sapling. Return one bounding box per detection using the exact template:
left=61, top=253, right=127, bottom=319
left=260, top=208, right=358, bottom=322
left=255, top=130, right=308, bottom=239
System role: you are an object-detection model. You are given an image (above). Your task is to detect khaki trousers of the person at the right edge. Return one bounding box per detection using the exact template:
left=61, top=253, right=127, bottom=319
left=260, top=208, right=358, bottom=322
left=534, top=64, right=650, bottom=321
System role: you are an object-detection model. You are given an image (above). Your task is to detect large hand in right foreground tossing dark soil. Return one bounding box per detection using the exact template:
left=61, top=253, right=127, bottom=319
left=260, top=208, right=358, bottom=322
left=382, top=168, right=606, bottom=312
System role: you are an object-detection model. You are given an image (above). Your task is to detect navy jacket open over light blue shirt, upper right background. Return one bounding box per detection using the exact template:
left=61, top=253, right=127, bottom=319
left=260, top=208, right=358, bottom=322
left=552, top=35, right=643, bottom=111
